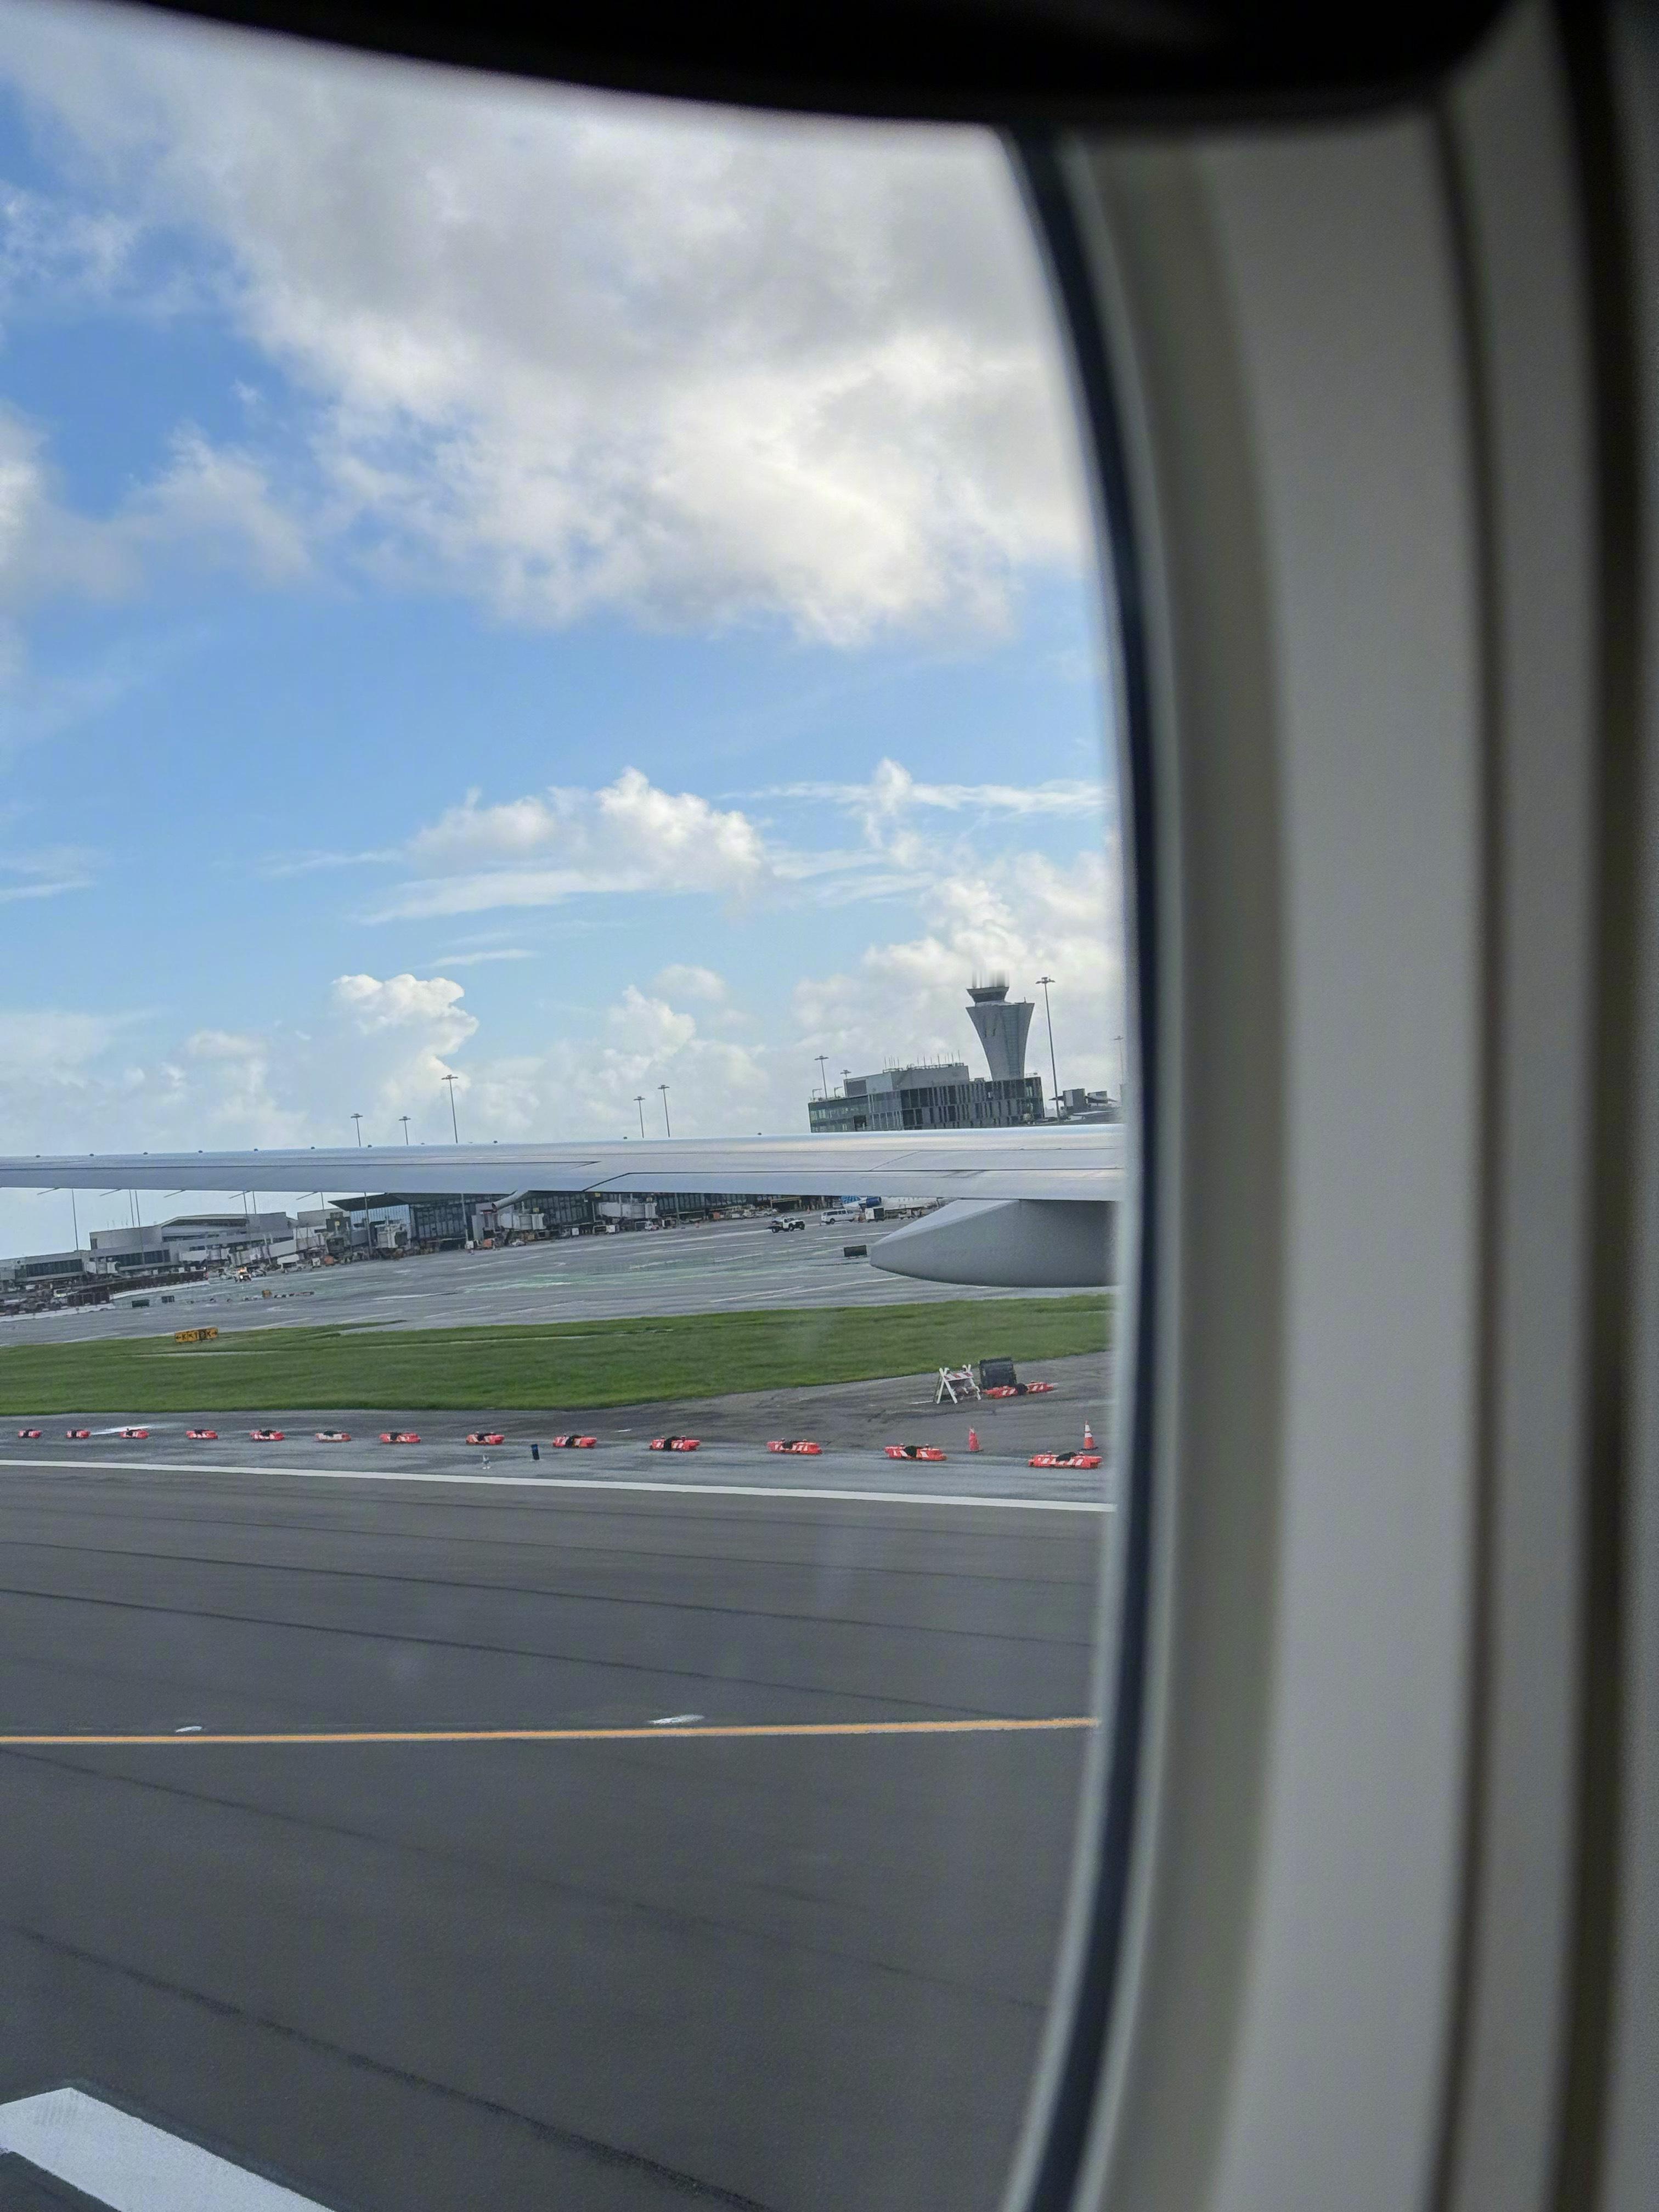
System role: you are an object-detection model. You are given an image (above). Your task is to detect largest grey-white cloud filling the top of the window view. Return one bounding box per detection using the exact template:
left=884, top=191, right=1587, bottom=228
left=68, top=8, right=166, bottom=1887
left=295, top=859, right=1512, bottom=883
left=7, top=9, right=1086, bottom=641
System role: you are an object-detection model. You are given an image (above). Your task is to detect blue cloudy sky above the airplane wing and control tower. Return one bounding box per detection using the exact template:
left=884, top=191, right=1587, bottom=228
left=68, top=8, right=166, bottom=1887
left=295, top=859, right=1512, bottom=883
left=0, top=0, right=1124, bottom=1252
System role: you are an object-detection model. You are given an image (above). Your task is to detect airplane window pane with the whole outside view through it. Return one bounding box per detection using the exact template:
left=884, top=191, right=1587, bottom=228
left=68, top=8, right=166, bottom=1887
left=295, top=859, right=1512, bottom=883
left=0, top=0, right=1132, bottom=2212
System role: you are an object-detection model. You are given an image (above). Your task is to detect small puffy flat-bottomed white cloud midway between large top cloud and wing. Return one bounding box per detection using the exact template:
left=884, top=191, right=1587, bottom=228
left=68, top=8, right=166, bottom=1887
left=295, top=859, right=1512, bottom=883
left=369, top=768, right=768, bottom=922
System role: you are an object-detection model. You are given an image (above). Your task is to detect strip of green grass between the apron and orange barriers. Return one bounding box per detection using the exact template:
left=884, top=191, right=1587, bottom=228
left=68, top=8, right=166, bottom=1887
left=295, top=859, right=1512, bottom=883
left=0, top=1296, right=1110, bottom=1413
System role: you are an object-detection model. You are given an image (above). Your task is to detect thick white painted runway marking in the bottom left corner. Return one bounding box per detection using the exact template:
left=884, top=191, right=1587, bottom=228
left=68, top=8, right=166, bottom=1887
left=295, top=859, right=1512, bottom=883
left=0, top=2088, right=325, bottom=2212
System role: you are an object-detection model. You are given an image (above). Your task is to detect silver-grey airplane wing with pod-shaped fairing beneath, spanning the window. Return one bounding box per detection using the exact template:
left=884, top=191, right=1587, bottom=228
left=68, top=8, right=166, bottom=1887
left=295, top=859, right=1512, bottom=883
left=0, top=1121, right=1124, bottom=1288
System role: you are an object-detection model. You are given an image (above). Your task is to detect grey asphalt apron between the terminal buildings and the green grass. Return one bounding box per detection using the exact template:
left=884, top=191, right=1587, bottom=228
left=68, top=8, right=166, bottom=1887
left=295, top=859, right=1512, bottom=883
left=0, top=1217, right=1097, bottom=1347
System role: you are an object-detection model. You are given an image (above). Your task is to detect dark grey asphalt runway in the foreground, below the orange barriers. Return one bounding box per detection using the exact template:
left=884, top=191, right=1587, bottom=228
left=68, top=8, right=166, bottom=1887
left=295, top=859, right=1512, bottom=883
left=0, top=1442, right=1113, bottom=2212
